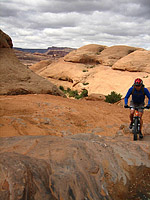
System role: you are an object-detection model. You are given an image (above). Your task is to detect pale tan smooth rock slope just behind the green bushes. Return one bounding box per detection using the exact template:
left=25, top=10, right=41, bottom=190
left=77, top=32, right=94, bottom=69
left=38, top=59, right=150, bottom=96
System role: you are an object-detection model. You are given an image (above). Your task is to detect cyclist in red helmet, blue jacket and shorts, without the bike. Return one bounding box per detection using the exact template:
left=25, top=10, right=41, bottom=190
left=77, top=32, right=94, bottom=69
left=124, top=78, right=150, bottom=138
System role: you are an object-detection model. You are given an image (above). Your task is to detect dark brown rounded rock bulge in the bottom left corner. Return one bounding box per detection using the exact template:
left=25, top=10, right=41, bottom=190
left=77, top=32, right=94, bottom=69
left=0, top=152, right=56, bottom=200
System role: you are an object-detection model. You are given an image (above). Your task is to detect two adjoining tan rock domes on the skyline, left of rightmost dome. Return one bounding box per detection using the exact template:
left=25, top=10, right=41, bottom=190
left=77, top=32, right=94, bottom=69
left=64, top=44, right=140, bottom=66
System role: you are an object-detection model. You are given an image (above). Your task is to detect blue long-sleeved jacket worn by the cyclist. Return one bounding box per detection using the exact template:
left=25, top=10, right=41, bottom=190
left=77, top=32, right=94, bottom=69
left=124, top=86, right=150, bottom=105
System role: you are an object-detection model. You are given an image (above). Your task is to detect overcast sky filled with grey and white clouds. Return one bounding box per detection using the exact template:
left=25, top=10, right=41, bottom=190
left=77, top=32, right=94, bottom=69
left=0, top=0, right=150, bottom=50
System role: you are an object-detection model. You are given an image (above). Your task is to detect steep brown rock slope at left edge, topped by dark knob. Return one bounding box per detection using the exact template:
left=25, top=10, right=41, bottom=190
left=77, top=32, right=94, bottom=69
left=0, top=29, right=64, bottom=96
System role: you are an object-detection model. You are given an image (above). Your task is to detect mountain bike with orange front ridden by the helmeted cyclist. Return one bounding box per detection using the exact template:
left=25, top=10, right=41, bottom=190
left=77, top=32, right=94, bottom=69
left=127, top=106, right=147, bottom=141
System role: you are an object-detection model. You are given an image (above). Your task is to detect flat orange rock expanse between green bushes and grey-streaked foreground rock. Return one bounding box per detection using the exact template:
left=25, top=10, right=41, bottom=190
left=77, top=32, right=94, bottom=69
left=0, top=94, right=150, bottom=137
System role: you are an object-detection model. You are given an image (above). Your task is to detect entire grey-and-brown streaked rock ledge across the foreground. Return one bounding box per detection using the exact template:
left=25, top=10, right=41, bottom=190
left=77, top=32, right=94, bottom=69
left=0, top=133, right=150, bottom=200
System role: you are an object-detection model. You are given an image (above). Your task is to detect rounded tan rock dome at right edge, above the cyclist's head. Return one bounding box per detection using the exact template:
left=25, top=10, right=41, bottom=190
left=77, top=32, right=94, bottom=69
left=112, top=50, right=150, bottom=73
